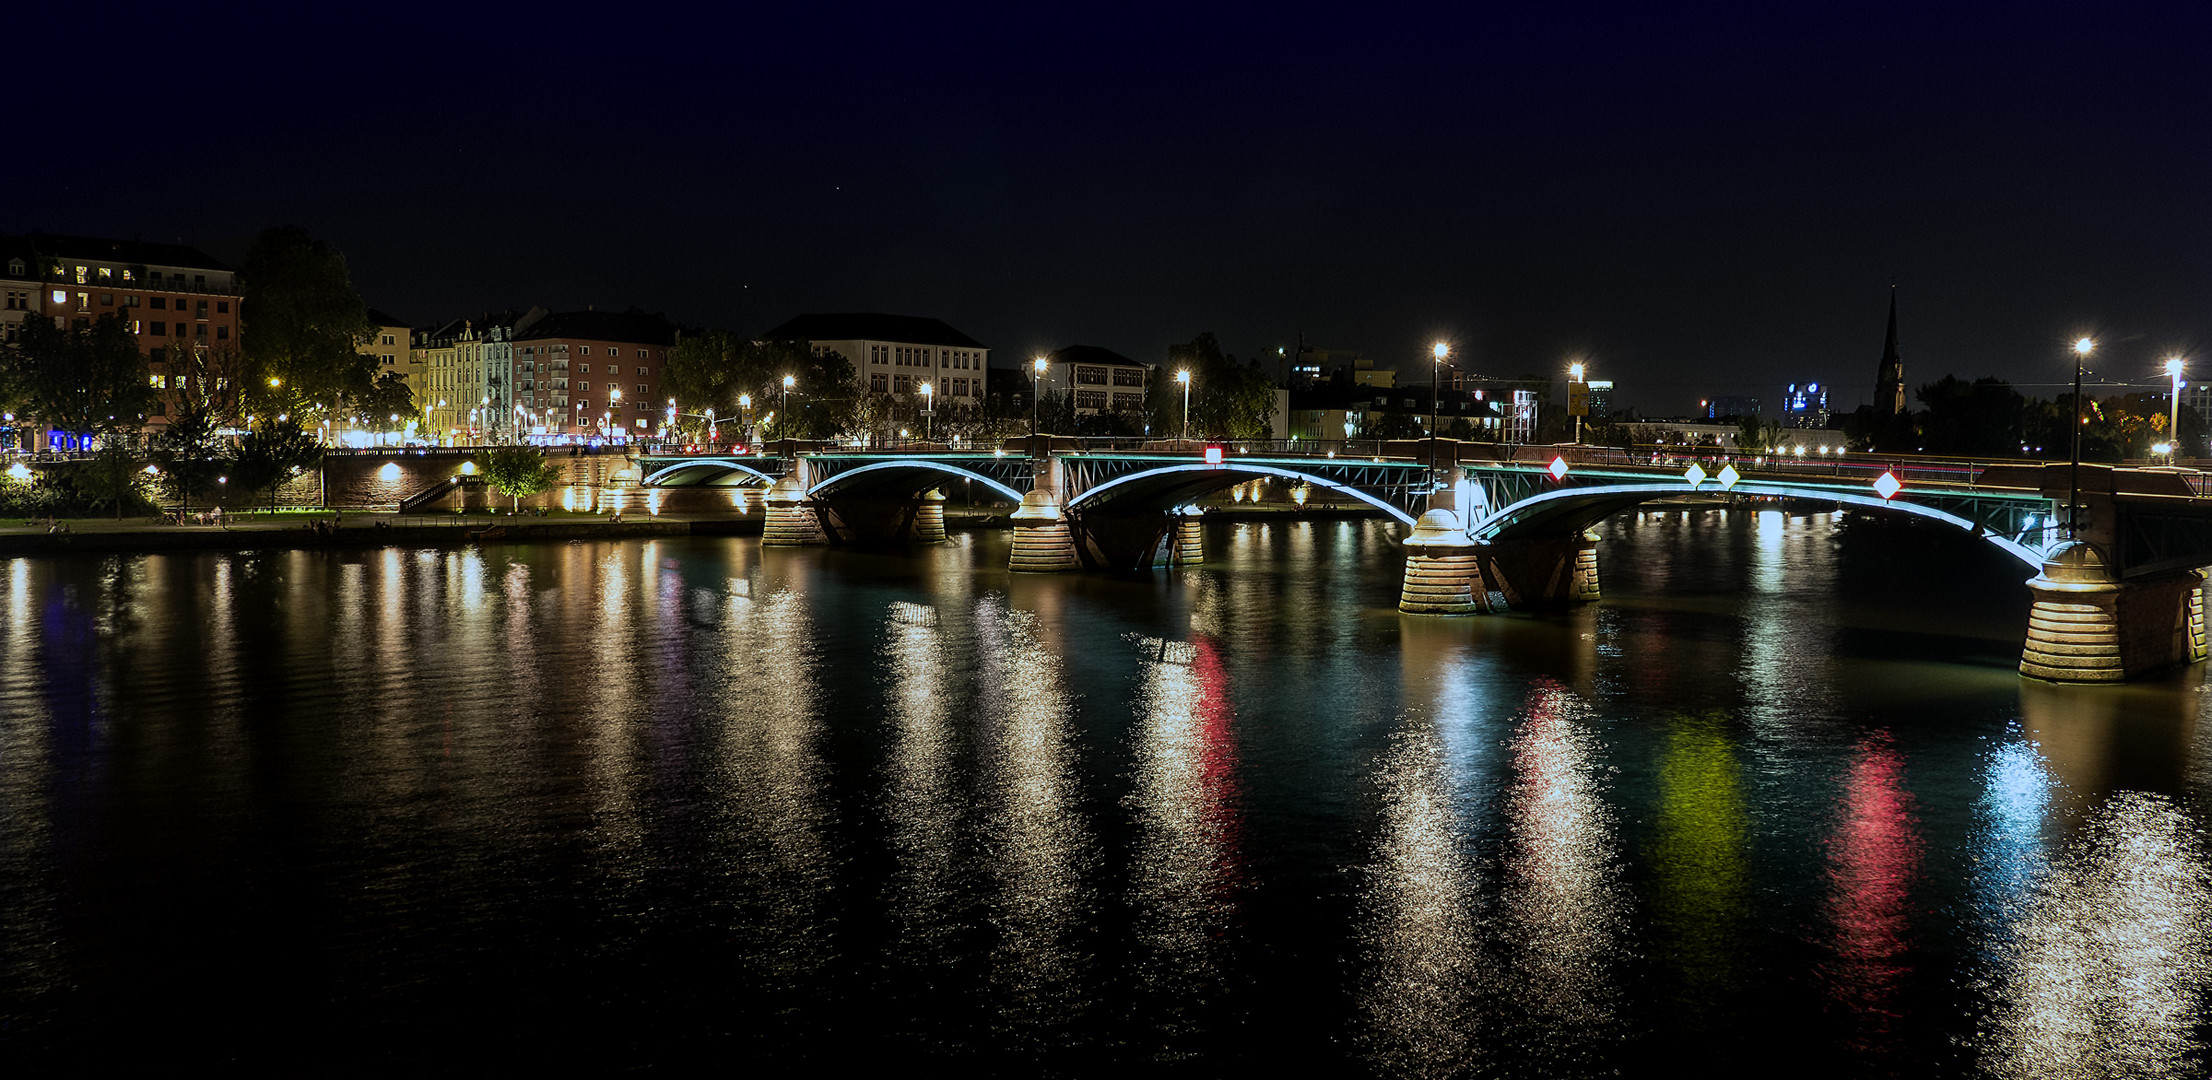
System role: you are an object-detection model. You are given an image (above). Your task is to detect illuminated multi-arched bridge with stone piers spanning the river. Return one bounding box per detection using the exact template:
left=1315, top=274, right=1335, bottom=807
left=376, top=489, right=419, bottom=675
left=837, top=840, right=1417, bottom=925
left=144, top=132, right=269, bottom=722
left=644, top=436, right=2212, bottom=677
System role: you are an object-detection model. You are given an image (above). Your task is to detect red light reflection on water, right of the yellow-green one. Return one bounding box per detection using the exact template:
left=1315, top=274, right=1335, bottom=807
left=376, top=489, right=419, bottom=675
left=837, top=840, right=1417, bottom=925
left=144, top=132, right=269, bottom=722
left=1827, top=733, right=1920, bottom=1049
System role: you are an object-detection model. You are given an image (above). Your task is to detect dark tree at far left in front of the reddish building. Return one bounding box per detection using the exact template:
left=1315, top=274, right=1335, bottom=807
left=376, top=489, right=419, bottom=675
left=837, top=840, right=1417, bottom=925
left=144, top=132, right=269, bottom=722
left=7, top=314, right=159, bottom=436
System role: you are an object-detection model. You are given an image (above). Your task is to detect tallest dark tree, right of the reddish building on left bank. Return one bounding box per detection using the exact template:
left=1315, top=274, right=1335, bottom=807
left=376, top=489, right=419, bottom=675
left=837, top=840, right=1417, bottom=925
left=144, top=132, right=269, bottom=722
left=239, top=226, right=376, bottom=412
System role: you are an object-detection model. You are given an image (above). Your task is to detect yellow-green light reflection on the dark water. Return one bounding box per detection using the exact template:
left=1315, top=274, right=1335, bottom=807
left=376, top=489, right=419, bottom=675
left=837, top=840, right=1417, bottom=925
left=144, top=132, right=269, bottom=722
left=1650, top=715, right=1745, bottom=1009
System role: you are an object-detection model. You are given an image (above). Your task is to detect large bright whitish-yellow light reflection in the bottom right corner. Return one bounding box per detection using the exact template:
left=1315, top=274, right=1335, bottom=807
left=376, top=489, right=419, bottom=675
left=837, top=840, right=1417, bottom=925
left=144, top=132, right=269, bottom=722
left=1982, top=792, right=2212, bottom=1078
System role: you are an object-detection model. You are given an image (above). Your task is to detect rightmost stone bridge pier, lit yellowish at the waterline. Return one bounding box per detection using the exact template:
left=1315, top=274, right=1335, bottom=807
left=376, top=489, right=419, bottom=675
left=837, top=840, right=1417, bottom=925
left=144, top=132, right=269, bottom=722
left=2020, top=542, right=2205, bottom=682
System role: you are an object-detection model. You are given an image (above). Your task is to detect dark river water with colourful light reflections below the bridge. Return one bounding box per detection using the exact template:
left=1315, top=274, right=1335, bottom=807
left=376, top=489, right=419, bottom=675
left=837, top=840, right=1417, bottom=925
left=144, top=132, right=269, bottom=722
left=0, top=509, right=2212, bottom=1078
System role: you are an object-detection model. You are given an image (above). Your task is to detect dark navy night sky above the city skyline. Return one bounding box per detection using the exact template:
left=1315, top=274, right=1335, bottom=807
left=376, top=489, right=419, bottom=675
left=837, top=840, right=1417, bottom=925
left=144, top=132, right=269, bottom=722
left=17, top=4, right=2212, bottom=414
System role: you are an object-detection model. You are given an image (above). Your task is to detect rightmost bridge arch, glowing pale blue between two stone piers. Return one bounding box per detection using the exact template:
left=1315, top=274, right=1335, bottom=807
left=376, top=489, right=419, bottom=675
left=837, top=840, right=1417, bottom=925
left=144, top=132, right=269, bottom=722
left=1467, top=480, right=2051, bottom=569
